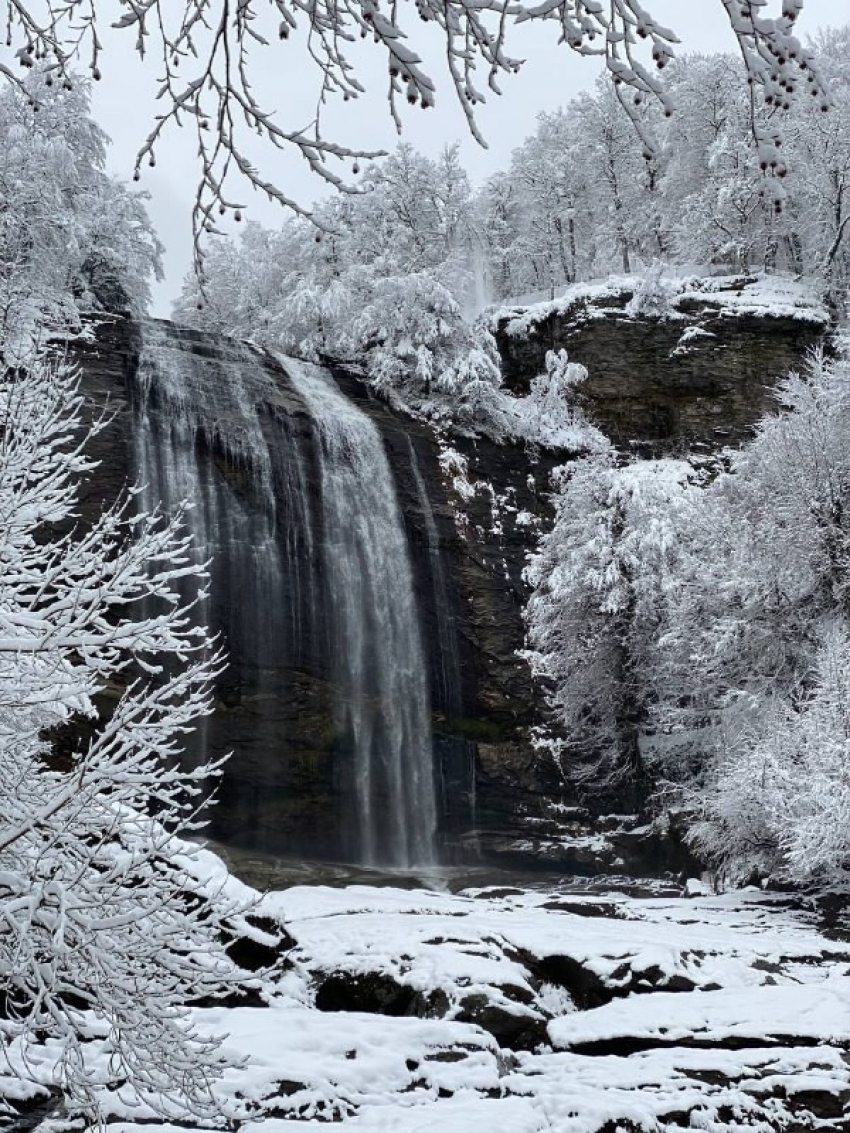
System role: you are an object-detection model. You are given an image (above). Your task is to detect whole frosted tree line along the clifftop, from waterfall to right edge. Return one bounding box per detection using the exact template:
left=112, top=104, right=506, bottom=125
left=176, top=27, right=850, bottom=418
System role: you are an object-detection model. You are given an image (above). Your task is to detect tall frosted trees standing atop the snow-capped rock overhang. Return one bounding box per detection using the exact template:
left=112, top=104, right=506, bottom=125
left=478, top=36, right=850, bottom=303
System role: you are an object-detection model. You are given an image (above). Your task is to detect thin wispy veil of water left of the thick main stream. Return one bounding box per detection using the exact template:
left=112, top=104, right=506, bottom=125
left=134, top=321, right=316, bottom=806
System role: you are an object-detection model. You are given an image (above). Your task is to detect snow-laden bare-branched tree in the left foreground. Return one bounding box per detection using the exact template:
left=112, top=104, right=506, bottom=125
left=0, top=359, right=249, bottom=1119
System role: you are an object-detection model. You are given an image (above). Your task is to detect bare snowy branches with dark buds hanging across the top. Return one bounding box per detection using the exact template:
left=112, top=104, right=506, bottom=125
left=0, top=0, right=828, bottom=246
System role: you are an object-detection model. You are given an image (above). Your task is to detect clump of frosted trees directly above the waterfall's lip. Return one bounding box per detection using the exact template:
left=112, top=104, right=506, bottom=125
left=176, top=146, right=501, bottom=418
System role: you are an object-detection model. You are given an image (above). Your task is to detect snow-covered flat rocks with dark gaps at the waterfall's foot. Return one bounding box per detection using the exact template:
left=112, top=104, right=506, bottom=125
left=7, top=861, right=850, bottom=1133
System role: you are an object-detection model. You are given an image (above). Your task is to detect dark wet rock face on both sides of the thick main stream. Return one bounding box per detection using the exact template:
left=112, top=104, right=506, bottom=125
left=71, top=321, right=555, bottom=859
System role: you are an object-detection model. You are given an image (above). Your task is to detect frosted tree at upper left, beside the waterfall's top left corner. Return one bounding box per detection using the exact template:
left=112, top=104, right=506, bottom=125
left=0, top=70, right=160, bottom=357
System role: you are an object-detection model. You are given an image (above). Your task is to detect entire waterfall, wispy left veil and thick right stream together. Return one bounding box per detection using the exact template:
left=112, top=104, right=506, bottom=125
left=136, top=322, right=439, bottom=869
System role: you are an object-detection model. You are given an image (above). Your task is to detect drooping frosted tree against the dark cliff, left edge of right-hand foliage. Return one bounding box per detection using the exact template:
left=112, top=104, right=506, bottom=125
left=527, top=451, right=694, bottom=801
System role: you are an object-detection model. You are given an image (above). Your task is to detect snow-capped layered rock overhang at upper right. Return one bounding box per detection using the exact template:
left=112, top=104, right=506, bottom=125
left=495, top=279, right=827, bottom=454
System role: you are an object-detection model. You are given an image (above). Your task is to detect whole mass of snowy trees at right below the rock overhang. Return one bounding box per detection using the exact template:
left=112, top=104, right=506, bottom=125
left=528, top=344, right=850, bottom=883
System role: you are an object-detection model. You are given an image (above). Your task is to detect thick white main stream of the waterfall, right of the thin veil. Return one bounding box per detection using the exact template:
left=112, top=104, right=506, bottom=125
left=281, top=358, right=436, bottom=868
